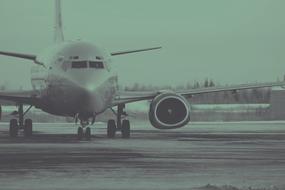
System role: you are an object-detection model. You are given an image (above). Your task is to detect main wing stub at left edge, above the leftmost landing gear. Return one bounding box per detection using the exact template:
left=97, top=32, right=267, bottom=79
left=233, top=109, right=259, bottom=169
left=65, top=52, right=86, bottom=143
left=0, top=90, right=39, bottom=105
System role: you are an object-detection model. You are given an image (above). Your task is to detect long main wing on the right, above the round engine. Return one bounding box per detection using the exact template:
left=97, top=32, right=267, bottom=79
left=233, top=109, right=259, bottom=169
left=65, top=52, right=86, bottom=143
left=113, top=82, right=285, bottom=106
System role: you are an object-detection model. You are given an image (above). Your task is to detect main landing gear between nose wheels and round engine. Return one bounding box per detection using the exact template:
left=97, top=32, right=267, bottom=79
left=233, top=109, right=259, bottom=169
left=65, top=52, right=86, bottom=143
left=107, top=104, right=130, bottom=139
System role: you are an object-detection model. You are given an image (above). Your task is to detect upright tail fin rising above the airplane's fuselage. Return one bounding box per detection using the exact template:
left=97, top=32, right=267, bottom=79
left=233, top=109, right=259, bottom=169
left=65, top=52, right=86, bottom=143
left=54, top=0, right=64, bottom=43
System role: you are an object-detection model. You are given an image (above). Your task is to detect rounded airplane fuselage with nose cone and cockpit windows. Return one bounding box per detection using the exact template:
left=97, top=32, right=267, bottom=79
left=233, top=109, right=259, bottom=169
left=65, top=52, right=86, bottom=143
left=31, top=41, right=118, bottom=120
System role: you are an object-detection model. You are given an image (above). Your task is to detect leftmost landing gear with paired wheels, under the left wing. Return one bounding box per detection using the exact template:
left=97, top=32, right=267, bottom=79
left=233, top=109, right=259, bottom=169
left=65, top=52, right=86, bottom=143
left=9, top=104, right=33, bottom=137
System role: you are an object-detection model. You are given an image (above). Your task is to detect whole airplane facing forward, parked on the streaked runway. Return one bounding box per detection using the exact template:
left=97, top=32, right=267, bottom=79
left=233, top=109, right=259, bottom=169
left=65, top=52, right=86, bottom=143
left=0, top=0, right=284, bottom=140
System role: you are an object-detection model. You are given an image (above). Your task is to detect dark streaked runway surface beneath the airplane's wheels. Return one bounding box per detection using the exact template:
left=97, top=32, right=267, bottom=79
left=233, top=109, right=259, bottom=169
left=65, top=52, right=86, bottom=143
left=0, top=122, right=285, bottom=190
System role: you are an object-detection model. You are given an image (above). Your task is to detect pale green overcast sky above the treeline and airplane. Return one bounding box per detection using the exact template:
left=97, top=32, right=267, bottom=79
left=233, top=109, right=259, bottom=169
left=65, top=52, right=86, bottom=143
left=0, top=0, right=285, bottom=88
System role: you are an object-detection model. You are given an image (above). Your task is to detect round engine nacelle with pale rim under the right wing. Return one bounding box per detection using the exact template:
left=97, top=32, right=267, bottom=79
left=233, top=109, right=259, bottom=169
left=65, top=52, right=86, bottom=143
left=149, top=92, right=190, bottom=129
